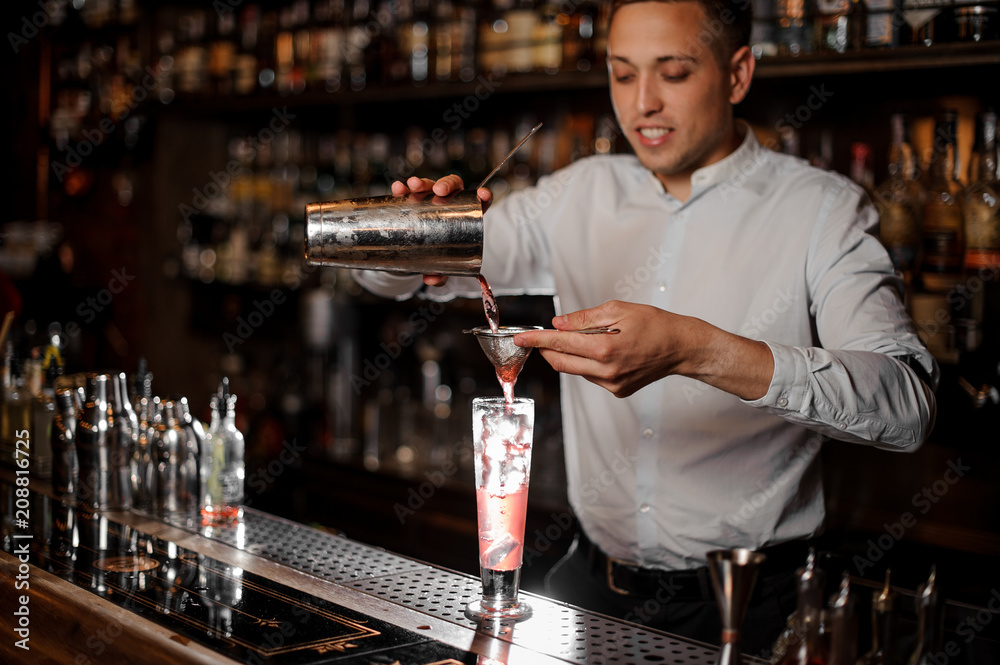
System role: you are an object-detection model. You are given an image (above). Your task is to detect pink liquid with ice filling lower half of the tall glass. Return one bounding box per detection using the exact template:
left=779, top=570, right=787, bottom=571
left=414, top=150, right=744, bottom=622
left=476, top=487, right=528, bottom=570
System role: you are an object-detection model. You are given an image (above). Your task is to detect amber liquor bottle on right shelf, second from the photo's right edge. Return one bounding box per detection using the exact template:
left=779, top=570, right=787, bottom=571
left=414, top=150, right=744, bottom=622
left=922, top=110, right=964, bottom=293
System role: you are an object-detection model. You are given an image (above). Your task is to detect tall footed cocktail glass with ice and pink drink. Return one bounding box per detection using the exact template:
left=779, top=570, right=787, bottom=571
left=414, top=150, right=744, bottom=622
left=465, top=397, right=535, bottom=621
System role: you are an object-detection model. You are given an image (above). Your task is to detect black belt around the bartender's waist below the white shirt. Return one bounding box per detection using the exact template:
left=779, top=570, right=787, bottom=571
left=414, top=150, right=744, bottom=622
left=577, top=531, right=809, bottom=601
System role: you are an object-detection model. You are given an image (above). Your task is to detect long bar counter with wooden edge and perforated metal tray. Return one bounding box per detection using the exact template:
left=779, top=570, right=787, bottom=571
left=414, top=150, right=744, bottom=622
left=0, top=469, right=740, bottom=665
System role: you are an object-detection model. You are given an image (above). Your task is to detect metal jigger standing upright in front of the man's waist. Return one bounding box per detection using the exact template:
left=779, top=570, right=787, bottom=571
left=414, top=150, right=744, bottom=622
left=705, top=549, right=766, bottom=665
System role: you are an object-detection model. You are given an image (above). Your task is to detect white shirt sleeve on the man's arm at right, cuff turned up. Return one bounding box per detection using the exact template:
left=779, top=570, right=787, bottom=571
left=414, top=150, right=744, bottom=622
left=746, top=180, right=938, bottom=451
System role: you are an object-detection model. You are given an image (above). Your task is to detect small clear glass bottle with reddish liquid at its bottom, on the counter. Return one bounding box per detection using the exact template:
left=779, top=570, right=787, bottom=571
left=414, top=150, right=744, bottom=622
left=201, top=378, right=245, bottom=524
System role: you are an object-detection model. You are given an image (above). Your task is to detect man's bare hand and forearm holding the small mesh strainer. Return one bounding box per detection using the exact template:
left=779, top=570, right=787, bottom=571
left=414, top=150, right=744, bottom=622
left=514, top=300, right=774, bottom=399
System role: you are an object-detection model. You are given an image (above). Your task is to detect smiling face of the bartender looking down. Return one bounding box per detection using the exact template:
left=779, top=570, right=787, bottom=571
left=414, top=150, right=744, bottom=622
left=608, top=1, right=733, bottom=188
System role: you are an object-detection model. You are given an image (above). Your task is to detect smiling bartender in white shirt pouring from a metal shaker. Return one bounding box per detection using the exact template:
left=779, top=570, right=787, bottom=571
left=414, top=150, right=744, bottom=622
left=359, top=0, right=938, bottom=653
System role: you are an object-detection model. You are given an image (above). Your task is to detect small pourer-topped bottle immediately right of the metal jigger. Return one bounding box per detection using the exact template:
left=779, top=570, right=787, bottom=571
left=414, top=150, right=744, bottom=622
left=771, top=549, right=824, bottom=665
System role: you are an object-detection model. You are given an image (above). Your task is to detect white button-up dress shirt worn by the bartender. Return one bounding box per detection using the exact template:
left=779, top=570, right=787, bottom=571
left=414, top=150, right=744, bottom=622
left=358, top=131, right=938, bottom=570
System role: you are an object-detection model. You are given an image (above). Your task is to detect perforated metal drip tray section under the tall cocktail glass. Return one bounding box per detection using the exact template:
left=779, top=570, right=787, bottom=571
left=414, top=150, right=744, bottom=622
left=350, top=567, right=718, bottom=665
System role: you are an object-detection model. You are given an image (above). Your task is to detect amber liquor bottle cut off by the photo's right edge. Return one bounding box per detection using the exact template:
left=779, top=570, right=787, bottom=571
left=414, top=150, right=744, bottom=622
left=963, top=111, right=1000, bottom=272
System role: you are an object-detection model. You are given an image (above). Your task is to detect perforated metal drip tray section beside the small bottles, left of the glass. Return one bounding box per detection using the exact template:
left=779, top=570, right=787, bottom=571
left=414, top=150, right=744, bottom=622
left=167, top=509, right=426, bottom=582
